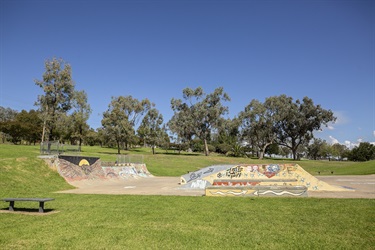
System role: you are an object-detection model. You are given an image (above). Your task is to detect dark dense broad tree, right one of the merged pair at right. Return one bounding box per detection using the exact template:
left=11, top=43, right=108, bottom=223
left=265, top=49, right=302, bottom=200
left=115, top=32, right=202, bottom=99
left=266, top=95, right=336, bottom=160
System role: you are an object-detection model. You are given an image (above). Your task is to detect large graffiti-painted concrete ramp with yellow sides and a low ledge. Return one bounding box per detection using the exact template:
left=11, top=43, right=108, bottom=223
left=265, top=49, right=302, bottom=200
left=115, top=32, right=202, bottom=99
left=181, top=164, right=351, bottom=196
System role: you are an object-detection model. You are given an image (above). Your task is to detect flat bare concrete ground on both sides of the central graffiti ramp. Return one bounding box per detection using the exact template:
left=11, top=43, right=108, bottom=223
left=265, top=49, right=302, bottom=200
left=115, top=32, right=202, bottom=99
left=59, top=175, right=375, bottom=199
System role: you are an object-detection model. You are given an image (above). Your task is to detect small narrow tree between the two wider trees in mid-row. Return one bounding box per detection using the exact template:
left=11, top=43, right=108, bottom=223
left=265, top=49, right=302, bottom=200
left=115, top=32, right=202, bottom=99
left=137, top=108, right=163, bottom=154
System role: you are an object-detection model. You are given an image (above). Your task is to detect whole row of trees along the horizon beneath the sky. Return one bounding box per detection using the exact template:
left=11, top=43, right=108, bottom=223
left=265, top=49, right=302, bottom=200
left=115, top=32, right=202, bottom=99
left=0, top=58, right=375, bottom=160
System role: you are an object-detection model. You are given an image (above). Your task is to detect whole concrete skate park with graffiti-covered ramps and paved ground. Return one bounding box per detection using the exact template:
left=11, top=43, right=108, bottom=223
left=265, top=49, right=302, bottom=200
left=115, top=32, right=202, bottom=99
left=47, top=156, right=375, bottom=199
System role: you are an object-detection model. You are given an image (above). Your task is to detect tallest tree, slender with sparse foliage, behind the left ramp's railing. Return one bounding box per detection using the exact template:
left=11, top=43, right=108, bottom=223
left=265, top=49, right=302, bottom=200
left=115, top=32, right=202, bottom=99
left=35, top=58, right=75, bottom=142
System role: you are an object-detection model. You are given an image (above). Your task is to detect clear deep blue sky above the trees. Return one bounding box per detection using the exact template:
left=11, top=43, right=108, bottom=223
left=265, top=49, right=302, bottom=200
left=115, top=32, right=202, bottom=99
left=0, top=0, right=375, bottom=145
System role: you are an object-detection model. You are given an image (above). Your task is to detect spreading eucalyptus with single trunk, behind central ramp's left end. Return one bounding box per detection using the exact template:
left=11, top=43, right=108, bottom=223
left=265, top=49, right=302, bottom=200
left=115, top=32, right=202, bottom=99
left=171, top=87, right=230, bottom=156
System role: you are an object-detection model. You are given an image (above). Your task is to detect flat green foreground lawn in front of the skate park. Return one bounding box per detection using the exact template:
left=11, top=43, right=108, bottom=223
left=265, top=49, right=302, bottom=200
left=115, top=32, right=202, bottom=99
left=0, top=193, right=375, bottom=249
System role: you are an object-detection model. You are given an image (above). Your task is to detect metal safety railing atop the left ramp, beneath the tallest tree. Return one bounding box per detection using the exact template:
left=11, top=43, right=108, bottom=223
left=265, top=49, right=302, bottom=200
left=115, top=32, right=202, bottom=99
left=40, top=141, right=81, bottom=155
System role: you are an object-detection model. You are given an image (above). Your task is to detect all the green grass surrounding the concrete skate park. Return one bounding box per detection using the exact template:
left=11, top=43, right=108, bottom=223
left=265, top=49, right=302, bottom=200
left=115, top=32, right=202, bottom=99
left=0, top=144, right=375, bottom=249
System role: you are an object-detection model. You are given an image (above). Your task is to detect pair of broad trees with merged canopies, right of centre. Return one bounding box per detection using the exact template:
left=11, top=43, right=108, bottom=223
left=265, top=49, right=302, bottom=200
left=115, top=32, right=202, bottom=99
left=240, top=95, right=336, bottom=159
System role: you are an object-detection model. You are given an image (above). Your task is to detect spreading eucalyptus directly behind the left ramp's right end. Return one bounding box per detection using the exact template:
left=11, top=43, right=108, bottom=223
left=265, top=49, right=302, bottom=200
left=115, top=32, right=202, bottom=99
left=102, top=96, right=151, bottom=154
